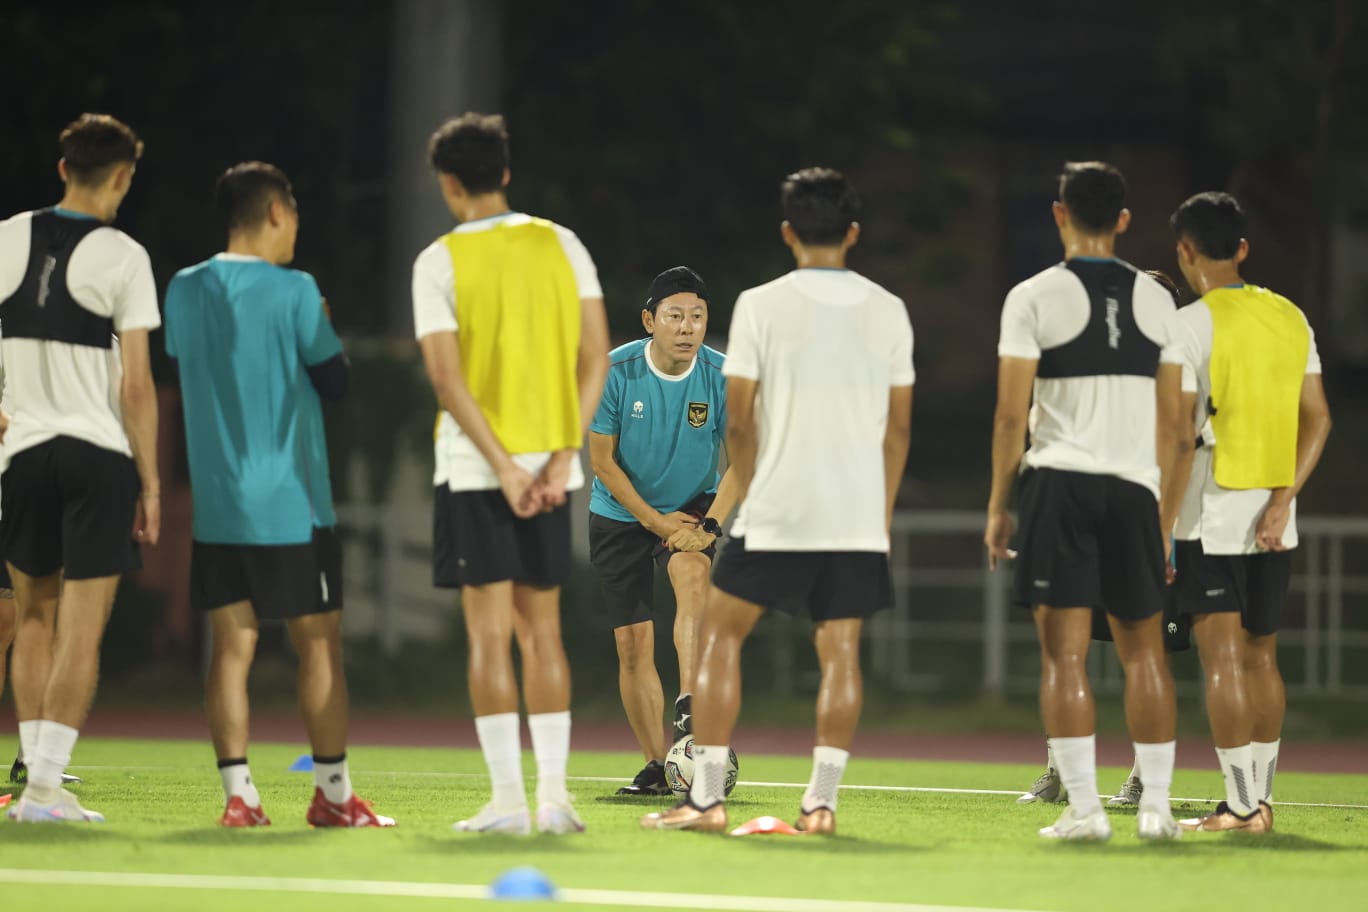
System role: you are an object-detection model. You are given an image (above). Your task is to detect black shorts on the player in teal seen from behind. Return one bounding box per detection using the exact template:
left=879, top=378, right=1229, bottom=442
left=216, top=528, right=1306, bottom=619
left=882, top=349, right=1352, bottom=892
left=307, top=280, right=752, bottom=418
left=190, top=528, right=342, bottom=621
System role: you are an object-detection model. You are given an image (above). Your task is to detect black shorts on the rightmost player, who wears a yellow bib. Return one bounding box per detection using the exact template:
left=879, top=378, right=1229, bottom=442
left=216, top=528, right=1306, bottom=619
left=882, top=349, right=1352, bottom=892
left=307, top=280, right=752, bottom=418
left=1174, top=541, right=1291, bottom=636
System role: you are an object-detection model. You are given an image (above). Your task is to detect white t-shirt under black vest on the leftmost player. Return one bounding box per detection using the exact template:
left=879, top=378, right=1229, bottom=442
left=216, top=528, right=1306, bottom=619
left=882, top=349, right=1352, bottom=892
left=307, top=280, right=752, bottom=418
left=0, top=212, right=161, bottom=468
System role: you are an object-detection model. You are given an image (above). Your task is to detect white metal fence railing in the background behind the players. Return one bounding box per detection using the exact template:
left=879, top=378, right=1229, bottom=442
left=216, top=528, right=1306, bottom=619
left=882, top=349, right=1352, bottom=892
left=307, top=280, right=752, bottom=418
left=331, top=503, right=1368, bottom=699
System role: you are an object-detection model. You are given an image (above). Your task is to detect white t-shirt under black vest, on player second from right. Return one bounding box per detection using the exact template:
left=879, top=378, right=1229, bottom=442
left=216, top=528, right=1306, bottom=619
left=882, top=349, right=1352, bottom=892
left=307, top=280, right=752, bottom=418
left=997, top=258, right=1178, bottom=498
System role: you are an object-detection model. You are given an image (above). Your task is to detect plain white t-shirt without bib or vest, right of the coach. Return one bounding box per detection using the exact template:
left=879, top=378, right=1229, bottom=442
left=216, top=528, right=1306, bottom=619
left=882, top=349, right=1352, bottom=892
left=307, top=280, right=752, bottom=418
left=722, top=263, right=915, bottom=552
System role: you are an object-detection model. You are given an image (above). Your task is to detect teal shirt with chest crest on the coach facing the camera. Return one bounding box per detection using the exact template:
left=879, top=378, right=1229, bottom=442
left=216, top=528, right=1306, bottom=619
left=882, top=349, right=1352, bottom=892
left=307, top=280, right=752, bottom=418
left=590, top=339, right=726, bottom=522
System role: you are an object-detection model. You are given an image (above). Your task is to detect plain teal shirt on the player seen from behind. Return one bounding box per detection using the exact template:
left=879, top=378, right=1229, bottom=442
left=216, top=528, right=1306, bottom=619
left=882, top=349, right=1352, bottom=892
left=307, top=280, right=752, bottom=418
left=164, top=254, right=342, bottom=544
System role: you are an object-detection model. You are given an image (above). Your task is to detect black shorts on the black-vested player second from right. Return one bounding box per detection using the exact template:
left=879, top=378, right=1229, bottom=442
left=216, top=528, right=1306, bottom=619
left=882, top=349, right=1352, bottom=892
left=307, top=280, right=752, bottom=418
left=1012, top=469, right=1164, bottom=621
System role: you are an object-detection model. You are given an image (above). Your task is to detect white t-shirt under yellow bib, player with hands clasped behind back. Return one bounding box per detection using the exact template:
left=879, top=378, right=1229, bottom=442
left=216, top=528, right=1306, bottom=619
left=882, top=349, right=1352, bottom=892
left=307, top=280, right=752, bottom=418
left=413, top=212, right=603, bottom=491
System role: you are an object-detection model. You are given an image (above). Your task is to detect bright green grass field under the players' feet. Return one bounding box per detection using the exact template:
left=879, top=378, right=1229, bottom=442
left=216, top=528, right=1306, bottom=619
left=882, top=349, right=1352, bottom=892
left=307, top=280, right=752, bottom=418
left=0, top=738, right=1368, bottom=912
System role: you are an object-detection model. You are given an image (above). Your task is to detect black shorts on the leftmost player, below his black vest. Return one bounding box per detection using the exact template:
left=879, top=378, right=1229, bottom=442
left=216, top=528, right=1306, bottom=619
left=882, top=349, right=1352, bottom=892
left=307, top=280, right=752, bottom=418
left=0, top=438, right=142, bottom=580
